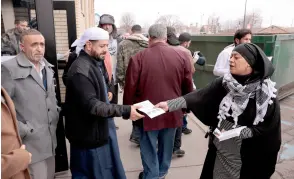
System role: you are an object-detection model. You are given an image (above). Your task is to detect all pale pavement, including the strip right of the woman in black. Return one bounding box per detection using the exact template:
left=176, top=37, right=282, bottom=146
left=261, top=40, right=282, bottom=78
left=56, top=95, right=294, bottom=179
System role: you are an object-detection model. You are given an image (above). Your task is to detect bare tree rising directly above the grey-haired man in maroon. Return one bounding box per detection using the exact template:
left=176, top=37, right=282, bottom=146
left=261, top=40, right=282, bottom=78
left=155, top=14, right=183, bottom=32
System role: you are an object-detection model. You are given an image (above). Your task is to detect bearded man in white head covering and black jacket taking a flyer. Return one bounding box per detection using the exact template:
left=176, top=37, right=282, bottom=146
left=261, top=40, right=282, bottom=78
left=64, top=27, right=144, bottom=179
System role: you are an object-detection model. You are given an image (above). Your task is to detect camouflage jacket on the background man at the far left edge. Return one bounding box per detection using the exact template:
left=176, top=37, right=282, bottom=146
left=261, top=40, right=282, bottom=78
left=1, top=28, right=20, bottom=55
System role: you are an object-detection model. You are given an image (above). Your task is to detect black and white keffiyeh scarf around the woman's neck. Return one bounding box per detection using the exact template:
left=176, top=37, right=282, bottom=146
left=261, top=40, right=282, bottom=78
left=217, top=73, right=277, bottom=128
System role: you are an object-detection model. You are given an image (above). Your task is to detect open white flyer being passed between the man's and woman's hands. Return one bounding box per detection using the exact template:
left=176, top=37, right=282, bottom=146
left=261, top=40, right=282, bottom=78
left=135, top=100, right=165, bottom=119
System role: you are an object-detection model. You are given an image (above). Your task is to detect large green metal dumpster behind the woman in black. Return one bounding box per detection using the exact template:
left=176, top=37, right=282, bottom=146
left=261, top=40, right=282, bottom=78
left=190, top=34, right=294, bottom=98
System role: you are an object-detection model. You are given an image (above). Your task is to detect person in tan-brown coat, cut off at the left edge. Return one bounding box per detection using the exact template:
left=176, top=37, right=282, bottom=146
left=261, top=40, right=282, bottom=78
left=1, top=88, right=31, bottom=179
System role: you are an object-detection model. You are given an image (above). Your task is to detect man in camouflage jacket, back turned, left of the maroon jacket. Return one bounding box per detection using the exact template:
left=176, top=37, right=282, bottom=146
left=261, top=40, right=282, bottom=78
left=116, top=25, right=148, bottom=144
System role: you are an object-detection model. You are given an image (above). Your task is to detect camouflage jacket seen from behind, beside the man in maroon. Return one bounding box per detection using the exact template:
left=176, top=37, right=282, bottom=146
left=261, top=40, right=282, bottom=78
left=116, top=34, right=148, bottom=88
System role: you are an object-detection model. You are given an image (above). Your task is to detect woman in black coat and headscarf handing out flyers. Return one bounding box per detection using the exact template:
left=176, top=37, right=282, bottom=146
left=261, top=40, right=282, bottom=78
left=157, top=44, right=281, bottom=179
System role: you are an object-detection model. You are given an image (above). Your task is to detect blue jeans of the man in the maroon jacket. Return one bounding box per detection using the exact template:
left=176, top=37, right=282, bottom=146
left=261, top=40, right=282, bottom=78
left=140, top=128, right=176, bottom=179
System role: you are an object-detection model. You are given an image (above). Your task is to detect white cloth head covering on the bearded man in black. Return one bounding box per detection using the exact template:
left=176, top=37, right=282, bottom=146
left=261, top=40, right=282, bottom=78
left=76, top=27, right=109, bottom=54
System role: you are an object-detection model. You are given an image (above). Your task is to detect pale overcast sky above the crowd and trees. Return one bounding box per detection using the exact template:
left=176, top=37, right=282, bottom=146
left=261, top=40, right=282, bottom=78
left=95, top=0, right=294, bottom=27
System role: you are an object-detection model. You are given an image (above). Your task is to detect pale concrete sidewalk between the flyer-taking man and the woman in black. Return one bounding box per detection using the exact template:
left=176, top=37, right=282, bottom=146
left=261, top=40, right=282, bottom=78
left=55, top=114, right=207, bottom=179
